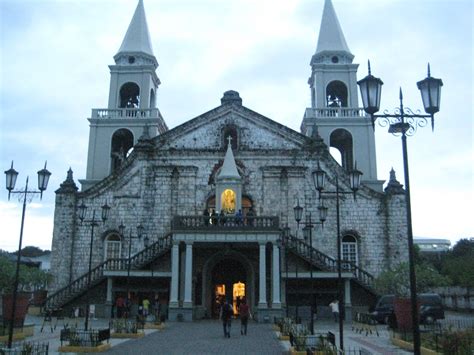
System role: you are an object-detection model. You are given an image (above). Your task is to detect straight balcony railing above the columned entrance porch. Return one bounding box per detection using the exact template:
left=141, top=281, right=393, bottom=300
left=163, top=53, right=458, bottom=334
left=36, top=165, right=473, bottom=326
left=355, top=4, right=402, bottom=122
left=172, top=216, right=280, bottom=232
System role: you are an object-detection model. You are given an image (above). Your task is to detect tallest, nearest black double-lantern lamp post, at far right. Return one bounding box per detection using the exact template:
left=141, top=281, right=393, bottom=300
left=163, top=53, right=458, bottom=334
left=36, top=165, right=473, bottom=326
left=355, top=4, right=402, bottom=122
left=357, top=61, right=443, bottom=355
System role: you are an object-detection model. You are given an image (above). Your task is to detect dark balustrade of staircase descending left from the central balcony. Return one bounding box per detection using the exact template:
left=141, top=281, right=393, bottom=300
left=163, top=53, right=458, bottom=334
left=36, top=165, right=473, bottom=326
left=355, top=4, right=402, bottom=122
left=45, top=233, right=172, bottom=310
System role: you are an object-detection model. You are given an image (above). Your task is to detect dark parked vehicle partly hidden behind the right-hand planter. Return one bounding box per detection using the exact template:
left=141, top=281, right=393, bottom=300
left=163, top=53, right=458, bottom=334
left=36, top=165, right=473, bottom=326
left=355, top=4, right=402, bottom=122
left=372, top=293, right=444, bottom=324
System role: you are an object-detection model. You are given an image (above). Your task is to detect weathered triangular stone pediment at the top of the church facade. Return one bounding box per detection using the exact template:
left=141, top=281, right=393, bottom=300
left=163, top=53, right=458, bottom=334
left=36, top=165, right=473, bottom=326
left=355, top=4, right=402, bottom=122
left=155, top=99, right=309, bottom=150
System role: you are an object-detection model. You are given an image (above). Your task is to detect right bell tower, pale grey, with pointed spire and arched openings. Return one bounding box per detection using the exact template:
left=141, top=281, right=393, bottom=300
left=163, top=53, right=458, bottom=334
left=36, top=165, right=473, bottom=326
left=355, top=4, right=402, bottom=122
left=301, top=0, right=383, bottom=192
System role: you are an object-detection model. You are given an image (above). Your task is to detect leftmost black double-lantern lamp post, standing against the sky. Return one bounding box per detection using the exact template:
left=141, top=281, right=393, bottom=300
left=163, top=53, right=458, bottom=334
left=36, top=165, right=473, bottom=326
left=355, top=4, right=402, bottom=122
left=5, top=161, right=51, bottom=349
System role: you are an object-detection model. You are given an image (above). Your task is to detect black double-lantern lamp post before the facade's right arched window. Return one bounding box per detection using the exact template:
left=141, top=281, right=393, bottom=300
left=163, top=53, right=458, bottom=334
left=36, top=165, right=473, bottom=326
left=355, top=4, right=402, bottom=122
left=312, top=162, right=362, bottom=350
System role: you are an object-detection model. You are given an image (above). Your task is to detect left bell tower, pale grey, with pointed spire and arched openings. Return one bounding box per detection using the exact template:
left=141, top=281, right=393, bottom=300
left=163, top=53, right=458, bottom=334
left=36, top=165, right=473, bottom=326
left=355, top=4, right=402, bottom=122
left=81, top=0, right=168, bottom=190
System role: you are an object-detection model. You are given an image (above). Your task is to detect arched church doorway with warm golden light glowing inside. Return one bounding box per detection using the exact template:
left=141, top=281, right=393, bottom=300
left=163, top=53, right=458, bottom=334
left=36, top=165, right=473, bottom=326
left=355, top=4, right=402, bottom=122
left=210, top=258, right=249, bottom=318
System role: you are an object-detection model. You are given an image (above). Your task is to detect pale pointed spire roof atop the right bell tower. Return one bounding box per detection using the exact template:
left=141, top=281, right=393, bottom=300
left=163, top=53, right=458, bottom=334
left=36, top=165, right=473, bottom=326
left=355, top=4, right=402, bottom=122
left=316, top=0, right=351, bottom=54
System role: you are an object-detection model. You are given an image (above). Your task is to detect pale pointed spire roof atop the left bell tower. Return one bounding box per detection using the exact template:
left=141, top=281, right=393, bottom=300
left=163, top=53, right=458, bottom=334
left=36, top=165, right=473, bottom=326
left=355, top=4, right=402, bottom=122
left=118, top=0, right=154, bottom=56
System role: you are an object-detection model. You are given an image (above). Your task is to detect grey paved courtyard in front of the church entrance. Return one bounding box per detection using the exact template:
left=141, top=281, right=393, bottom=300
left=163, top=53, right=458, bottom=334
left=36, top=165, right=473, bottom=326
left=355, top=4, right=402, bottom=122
left=9, top=312, right=474, bottom=355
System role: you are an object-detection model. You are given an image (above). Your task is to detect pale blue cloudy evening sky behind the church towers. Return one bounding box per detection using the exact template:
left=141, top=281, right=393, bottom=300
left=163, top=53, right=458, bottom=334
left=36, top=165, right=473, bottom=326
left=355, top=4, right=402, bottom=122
left=0, top=0, right=474, bottom=251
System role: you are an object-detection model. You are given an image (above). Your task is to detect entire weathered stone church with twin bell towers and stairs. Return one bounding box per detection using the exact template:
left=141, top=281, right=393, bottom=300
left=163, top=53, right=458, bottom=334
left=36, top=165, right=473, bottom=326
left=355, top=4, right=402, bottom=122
left=47, top=0, right=407, bottom=320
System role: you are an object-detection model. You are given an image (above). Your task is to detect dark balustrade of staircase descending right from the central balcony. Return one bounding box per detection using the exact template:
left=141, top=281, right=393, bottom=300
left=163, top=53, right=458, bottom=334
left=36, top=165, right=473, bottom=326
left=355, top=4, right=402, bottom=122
left=282, top=235, right=376, bottom=295
